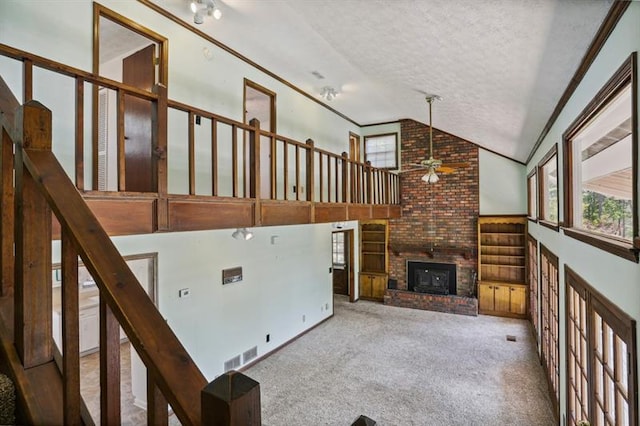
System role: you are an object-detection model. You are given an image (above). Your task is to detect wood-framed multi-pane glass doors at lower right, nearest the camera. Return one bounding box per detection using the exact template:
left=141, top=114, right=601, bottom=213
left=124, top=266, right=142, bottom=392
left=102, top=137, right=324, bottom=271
left=565, top=266, right=638, bottom=425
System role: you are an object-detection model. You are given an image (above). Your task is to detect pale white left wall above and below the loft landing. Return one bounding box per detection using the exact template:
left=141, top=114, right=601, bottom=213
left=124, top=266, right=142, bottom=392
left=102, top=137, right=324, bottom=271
left=0, top=0, right=360, bottom=396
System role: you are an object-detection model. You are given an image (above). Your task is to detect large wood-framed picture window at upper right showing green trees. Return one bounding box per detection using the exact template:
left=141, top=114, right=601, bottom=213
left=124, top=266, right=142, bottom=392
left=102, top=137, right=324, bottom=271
left=564, top=54, right=638, bottom=260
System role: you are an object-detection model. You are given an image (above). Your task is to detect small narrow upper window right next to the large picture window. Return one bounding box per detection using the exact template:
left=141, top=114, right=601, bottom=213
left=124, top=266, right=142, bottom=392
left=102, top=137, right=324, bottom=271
left=538, top=145, right=558, bottom=230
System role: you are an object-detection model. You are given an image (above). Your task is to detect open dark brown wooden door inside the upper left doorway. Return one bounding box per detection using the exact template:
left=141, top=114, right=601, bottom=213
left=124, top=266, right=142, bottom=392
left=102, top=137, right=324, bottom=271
left=122, top=44, right=157, bottom=192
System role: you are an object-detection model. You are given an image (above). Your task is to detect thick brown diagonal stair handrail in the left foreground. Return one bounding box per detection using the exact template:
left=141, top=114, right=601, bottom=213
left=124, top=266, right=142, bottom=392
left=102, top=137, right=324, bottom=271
left=24, top=150, right=207, bottom=424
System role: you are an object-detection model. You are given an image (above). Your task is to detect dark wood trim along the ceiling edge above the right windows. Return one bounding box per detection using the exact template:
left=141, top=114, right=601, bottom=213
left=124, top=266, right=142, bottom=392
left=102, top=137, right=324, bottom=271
left=527, top=0, right=631, bottom=163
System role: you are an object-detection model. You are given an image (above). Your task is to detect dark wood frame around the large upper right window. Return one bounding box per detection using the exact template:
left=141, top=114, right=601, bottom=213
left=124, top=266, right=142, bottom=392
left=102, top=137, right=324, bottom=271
left=562, top=52, right=640, bottom=263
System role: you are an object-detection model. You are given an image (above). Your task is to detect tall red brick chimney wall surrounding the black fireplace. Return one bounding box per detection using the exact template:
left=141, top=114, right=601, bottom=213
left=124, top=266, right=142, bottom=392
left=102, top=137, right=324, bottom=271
left=389, top=120, right=480, bottom=296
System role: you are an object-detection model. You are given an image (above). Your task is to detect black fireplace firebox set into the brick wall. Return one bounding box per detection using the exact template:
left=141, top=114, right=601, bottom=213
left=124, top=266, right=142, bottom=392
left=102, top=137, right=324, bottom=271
left=407, top=261, right=457, bottom=295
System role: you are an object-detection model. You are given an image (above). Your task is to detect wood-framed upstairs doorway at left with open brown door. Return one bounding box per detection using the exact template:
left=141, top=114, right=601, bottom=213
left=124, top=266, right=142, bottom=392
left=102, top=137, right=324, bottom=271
left=92, top=4, right=167, bottom=192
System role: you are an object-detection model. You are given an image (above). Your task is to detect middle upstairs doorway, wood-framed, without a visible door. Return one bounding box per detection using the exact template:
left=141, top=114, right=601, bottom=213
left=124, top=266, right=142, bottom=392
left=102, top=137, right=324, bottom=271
left=244, top=78, right=276, bottom=199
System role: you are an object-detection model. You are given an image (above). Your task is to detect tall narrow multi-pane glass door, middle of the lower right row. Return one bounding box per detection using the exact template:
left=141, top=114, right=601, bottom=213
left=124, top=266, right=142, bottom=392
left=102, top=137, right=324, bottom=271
left=540, top=244, right=560, bottom=414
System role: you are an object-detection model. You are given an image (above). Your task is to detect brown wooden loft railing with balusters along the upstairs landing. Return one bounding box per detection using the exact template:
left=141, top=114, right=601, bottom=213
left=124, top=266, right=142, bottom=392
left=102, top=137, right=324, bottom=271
left=0, top=44, right=399, bottom=207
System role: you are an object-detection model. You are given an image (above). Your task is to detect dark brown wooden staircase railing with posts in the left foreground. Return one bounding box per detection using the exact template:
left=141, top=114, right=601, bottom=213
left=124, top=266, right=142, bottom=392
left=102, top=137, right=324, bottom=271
left=0, top=84, right=260, bottom=425
